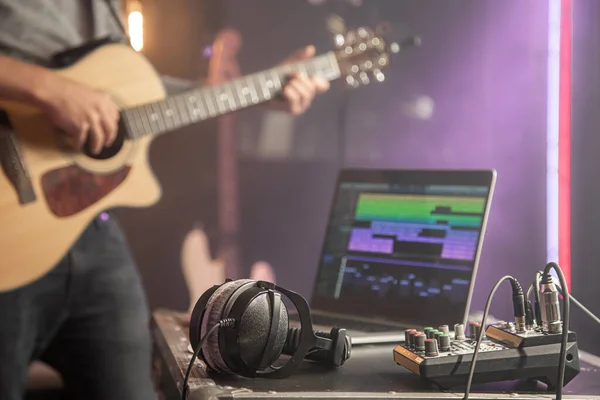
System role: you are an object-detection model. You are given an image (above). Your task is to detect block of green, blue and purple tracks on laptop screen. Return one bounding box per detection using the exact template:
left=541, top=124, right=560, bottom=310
left=348, top=194, right=485, bottom=260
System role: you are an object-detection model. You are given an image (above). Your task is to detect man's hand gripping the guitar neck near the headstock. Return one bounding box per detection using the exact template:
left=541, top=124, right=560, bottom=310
left=269, top=46, right=329, bottom=115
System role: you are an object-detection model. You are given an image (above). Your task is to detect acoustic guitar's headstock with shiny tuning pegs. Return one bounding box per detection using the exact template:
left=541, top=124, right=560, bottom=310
left=330, top=20, right=421, bottom=87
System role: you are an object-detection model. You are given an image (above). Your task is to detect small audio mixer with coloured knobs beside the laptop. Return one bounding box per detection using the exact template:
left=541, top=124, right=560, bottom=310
left=394, top=322, right=580, bottom=390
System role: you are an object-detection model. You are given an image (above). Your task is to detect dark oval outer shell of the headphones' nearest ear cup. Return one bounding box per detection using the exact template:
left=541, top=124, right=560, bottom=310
left=238, top=292, right=289, bottom=370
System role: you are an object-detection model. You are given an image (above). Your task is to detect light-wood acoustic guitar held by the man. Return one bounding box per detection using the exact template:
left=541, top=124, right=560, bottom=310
left=0, top=28, right=413, bottom=291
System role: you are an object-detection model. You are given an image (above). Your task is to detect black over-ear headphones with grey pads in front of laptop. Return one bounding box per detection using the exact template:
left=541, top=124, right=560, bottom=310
left=189, top=279, right=352, bottom=378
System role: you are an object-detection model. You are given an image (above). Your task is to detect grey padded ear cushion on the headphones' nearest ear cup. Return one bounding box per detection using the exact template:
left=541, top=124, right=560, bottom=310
left=201, top=279, right=253, bottom=373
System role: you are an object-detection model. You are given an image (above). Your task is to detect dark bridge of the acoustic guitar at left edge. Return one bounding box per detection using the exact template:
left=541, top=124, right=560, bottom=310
left=0, top=124, right=36, bottom=204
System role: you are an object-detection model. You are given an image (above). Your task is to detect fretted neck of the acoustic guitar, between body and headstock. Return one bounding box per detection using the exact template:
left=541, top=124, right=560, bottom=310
left=121, top=52, right=341, bottom=139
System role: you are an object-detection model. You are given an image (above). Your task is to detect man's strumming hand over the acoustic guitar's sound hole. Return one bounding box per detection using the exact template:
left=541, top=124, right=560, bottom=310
left=40, top=74, right=119, bottom=154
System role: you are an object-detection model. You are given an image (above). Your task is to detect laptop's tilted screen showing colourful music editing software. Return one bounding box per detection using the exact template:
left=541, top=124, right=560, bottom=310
left=311, top=170, right=496, bottom=326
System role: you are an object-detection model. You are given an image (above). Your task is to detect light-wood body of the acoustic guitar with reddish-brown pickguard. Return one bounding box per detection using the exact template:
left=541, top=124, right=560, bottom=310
left=0, top=44, right=165, bottom=291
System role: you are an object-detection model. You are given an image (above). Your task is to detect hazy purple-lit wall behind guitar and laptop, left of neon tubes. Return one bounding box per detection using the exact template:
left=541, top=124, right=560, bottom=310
left=115, top=0, right=548, bottom=332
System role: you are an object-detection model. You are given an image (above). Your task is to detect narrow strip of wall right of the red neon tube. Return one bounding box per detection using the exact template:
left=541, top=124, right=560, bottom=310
left=571, top=0, right=600, bottom=354
